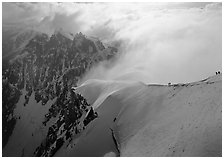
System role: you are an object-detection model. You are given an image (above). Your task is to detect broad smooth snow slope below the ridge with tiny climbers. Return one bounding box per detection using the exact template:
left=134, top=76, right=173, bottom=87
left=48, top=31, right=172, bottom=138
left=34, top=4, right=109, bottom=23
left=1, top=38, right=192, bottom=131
left=65, top=75, right=222, bottom=156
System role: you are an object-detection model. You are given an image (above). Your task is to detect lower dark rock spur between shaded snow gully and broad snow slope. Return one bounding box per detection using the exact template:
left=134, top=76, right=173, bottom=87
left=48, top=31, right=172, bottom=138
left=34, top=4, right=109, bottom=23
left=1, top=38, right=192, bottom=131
left=34, top=91, right=96, bottom=157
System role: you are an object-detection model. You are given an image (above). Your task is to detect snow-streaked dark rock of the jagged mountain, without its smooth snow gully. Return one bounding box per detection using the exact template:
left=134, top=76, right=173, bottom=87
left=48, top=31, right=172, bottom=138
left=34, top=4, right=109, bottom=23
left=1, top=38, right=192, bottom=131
left=2, top=32, right=117, bottom=156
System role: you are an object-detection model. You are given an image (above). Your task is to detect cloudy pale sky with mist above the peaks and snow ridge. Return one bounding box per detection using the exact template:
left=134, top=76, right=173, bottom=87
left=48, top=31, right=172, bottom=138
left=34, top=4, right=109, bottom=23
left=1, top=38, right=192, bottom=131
left=2, top=3, right=222, bottom=83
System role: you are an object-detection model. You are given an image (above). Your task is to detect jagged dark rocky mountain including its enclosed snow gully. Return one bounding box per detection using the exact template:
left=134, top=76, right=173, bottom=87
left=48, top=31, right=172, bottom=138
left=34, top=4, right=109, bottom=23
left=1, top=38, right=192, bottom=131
left=2, top=28, right=117, bottom=156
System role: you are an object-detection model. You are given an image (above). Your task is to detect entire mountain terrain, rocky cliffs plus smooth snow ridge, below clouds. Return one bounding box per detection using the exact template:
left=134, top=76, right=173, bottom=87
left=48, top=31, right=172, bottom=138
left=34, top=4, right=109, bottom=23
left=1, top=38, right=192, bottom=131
left=2, top=26, right=222, bottom=157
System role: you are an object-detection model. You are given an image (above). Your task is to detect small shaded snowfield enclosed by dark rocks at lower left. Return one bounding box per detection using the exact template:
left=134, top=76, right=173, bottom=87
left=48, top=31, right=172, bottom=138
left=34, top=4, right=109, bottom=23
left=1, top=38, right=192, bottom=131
left=3, top=89, right=57, bottom=157
